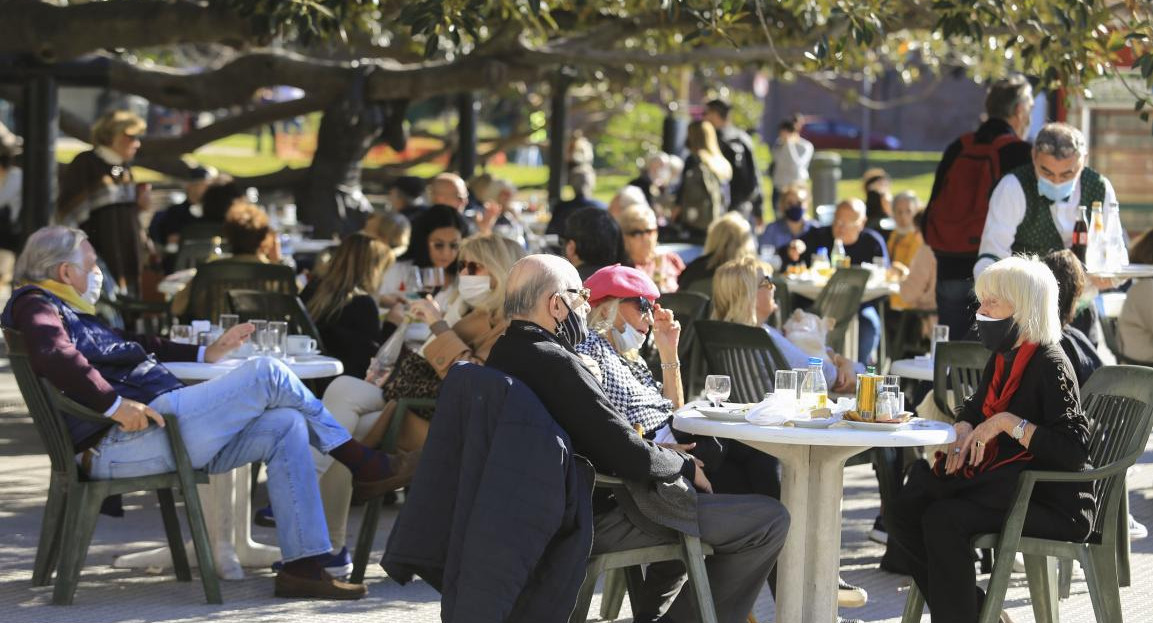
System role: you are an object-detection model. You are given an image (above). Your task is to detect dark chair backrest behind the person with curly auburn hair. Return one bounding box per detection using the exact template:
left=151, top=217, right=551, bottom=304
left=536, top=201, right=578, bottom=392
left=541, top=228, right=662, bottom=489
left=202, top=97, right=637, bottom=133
left=183, top=260, right=296, bottom=321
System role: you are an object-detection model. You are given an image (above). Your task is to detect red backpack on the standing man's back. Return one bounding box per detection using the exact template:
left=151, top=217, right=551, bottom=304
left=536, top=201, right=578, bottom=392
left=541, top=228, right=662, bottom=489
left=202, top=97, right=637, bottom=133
left=925, top=133, right=1020, bottom=256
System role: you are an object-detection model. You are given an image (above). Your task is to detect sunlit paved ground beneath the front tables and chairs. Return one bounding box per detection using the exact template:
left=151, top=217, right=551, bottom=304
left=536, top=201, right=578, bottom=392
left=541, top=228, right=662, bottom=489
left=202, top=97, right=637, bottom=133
left=0, top=360, right=1153, bottom=623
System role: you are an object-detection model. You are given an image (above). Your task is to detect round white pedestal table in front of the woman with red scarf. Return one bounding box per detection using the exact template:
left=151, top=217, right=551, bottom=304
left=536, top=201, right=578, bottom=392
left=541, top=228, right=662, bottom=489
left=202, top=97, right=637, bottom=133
left=673, top=410, right=956, bottom=623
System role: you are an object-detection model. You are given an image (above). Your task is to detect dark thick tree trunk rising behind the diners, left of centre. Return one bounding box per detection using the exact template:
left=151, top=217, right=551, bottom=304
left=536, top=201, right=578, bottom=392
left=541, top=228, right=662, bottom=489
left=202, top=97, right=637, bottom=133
left=296, top=74, right=407, bottom=238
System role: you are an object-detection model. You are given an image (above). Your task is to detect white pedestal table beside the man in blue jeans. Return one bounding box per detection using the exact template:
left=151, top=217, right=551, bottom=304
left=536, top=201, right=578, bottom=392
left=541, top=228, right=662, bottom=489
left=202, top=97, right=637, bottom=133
left=112, top=355, right=345, bottom=579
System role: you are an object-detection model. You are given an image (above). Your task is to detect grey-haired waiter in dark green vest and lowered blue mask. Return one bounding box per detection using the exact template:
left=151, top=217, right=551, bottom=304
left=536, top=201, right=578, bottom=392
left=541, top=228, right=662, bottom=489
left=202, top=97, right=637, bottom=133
left=973, top=123, right=1117, bottom=277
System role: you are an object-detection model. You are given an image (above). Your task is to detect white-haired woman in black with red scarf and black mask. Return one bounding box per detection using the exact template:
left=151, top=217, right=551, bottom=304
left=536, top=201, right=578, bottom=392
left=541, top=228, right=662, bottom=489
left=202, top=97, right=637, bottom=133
left=886, top=257, right=1095, bottom=623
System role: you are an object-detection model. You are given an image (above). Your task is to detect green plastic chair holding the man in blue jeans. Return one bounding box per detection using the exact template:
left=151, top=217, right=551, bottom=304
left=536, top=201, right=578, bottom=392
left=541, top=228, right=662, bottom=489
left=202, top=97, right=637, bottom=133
left=3, top=328, right=223, bottom=606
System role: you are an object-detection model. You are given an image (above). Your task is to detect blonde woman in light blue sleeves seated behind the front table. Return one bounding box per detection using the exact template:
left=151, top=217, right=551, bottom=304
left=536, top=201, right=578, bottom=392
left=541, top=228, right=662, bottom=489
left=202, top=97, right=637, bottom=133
left=713, top=257, right=864, bottom=392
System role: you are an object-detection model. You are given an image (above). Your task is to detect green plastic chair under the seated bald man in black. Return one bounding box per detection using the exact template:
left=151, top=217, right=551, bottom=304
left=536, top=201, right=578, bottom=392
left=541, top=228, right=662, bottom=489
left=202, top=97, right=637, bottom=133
left=568, top=474, right=717, bottom=623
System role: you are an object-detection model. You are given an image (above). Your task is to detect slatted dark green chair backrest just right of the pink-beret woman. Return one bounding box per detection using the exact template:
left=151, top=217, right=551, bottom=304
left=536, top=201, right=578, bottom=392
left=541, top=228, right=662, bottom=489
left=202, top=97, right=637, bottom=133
left=696, top=321, right=789, bottom=403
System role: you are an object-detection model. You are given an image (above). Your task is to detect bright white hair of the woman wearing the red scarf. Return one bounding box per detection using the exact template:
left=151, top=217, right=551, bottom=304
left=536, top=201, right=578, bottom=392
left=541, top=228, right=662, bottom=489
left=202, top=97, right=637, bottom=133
left=975, top=255, right=1061, bottom=346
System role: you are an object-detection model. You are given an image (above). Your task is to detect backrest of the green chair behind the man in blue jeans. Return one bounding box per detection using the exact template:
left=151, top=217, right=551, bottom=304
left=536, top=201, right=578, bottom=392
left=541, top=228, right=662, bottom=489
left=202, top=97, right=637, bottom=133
left=3, top=328, right=80, bottom=482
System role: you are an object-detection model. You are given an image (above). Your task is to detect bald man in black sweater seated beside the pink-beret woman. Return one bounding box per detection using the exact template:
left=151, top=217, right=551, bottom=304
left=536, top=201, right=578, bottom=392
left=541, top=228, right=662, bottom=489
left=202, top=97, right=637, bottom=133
left=487, top=255, right=789, bottom=623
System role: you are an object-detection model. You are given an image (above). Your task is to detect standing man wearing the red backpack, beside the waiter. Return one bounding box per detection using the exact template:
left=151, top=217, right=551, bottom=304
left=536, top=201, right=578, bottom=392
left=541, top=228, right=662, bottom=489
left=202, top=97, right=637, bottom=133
left=927, top=76, right=1033, bottom=339
